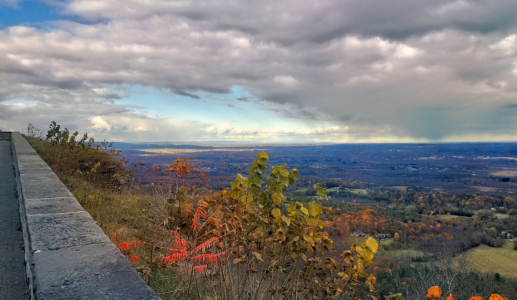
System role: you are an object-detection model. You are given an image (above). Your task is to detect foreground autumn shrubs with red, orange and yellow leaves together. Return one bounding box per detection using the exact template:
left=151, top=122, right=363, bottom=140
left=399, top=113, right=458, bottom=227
left=118, top=152, right=378, bottom=299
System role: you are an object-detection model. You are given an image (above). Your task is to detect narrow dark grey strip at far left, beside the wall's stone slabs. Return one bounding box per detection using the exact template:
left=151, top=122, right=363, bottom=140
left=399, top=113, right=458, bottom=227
left=0, top=132, right=29, bottom=300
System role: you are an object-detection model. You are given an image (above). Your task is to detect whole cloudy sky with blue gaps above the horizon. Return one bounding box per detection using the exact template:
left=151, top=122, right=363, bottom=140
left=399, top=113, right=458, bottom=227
left=0, top=0, right=517, bottom=143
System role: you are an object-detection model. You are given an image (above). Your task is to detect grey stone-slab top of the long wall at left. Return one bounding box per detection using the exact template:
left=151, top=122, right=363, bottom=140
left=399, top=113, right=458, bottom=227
left=11, top=132, right=159, bottom=300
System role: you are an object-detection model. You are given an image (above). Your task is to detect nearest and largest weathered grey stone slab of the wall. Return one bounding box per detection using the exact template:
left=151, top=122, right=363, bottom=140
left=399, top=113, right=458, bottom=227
left=31, top=242, right=159, bottom=300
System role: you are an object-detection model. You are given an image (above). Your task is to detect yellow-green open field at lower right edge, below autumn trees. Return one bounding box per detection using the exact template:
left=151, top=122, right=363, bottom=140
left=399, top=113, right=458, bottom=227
left=452, top=241, right=517, bottom=278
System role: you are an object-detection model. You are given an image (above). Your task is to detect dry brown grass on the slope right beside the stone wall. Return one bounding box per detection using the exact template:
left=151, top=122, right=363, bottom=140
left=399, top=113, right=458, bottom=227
left=27, top=138, right=189, bottom=299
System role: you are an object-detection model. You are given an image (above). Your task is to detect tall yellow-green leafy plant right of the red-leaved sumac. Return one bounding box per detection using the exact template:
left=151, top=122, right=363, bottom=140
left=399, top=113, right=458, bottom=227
left=223, top=152, right=377, bottom=299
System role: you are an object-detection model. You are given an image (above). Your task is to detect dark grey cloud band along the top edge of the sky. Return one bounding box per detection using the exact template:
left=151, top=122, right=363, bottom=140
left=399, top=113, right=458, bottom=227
left=67, top=0, right=517, bottom=45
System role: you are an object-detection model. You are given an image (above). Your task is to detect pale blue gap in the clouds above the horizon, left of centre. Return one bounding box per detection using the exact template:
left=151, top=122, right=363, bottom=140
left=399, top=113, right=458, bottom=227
left=111, top=85, right=313, bottom=130
